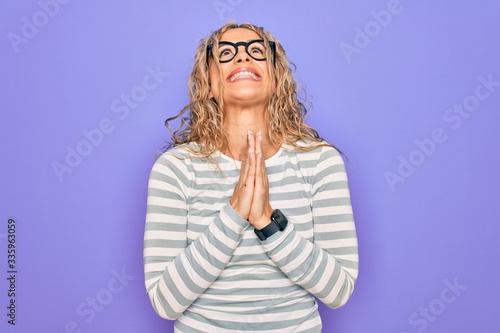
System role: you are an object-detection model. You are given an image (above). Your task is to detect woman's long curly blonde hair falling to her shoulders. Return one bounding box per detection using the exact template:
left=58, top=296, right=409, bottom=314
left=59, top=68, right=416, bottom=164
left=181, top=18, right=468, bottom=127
left=165, top=23, right=329, bottom=158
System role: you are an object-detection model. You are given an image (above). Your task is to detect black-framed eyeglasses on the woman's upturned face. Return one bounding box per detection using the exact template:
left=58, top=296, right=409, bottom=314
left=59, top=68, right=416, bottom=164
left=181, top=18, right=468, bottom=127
left=207, top=39, right=276, bottom=65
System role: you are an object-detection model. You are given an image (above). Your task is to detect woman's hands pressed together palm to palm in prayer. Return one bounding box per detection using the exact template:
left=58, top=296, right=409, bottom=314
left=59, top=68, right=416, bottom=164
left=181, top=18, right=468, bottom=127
left=229, top=130, right=273, bottom=229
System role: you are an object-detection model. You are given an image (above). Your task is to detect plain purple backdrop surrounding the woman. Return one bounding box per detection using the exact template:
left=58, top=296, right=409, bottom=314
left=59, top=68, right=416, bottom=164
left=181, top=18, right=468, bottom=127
left=0, top=0, right=500, bottom=333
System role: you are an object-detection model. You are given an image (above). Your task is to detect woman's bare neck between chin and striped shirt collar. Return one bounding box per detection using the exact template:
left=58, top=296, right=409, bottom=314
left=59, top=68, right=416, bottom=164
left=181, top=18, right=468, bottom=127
left=221, top=107, right=280, bottom=161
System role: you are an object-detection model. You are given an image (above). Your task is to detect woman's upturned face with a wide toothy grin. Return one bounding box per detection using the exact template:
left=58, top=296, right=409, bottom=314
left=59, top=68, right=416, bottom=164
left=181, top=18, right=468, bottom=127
left=210, top=28, right=272, bottom=106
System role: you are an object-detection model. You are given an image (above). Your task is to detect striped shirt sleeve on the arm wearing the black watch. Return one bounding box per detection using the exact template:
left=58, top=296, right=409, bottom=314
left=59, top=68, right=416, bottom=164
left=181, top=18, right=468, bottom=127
left=262, top=147, right=358, bottom=308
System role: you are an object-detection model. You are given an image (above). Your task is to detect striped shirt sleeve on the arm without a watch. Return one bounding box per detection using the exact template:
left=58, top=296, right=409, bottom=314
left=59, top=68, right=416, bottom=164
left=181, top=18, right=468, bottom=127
left=144, top=149, right=248, bottom=320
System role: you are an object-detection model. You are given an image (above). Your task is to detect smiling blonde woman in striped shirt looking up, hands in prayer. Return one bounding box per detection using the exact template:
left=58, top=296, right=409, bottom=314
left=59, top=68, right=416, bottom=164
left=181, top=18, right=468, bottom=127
left=144, top=24, right=358, bottom=333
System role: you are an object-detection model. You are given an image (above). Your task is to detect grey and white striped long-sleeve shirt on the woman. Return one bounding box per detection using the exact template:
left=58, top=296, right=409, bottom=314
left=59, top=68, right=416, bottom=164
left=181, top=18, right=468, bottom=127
left=144, top=143, right=358, bottom=333
